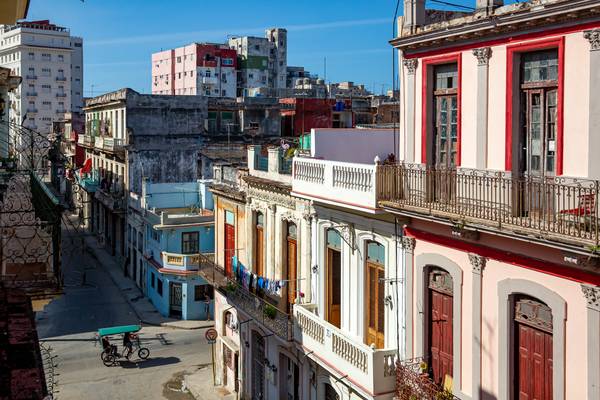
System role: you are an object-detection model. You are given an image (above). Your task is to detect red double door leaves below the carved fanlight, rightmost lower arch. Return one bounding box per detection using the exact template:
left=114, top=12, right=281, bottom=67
left=516, top=322, right=552, bottom=400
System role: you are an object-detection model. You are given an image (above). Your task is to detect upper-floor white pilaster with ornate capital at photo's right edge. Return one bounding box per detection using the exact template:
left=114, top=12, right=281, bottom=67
left=583, top=29, right=600, bottom=179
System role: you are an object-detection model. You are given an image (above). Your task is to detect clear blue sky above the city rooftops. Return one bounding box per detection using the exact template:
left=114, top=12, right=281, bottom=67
left=28, top=0, right=520, bottom=96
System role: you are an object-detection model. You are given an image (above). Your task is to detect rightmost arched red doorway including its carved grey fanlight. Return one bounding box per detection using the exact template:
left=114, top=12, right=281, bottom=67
left=513, top=295, right=553, bottom=400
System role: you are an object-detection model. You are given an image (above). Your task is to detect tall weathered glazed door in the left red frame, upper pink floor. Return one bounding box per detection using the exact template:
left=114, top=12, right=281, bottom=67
left=429, top=63, right=458, bottom=202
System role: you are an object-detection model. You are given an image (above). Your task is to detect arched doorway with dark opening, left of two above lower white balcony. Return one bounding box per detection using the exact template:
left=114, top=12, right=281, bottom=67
left=325, top=229, right=342, bottom=328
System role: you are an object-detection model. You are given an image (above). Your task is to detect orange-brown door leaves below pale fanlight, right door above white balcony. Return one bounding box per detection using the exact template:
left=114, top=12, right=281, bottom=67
left=365, top=262, right=385, bottom=349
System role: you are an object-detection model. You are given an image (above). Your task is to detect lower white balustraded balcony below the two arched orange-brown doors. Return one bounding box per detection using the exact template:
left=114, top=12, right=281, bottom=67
left=294, top=304, right=397, bottom=396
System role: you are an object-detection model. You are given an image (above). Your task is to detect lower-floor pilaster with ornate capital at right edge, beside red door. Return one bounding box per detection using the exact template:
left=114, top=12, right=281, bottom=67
left=581, top=284, right=600, bottom=399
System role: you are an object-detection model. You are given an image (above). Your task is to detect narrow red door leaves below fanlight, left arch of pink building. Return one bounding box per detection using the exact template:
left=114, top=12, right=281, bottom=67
left=429, top=289, right=453, bottom=385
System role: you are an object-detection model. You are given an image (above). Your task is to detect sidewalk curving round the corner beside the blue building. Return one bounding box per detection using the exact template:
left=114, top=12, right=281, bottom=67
left=85, top=236, right=214, bottom=329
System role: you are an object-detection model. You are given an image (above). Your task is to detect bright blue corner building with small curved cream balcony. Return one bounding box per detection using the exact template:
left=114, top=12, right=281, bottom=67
left=138, top=181, right=215, bottom=320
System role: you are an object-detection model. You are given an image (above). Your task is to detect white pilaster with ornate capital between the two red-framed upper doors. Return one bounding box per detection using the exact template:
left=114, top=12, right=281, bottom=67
left=473, top=47, right=492, bottom=169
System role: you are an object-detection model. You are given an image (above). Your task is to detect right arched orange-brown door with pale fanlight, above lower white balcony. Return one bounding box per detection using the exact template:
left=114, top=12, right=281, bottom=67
left=365, top=242, right=385, bottom=349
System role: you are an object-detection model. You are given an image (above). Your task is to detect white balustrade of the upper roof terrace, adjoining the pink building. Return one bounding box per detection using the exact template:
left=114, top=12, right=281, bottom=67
left=292, top=156, right=377, bottom=213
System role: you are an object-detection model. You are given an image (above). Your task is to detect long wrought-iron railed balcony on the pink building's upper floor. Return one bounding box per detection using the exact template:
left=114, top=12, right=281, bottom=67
left=377, top=164, right=600, bottom=247
